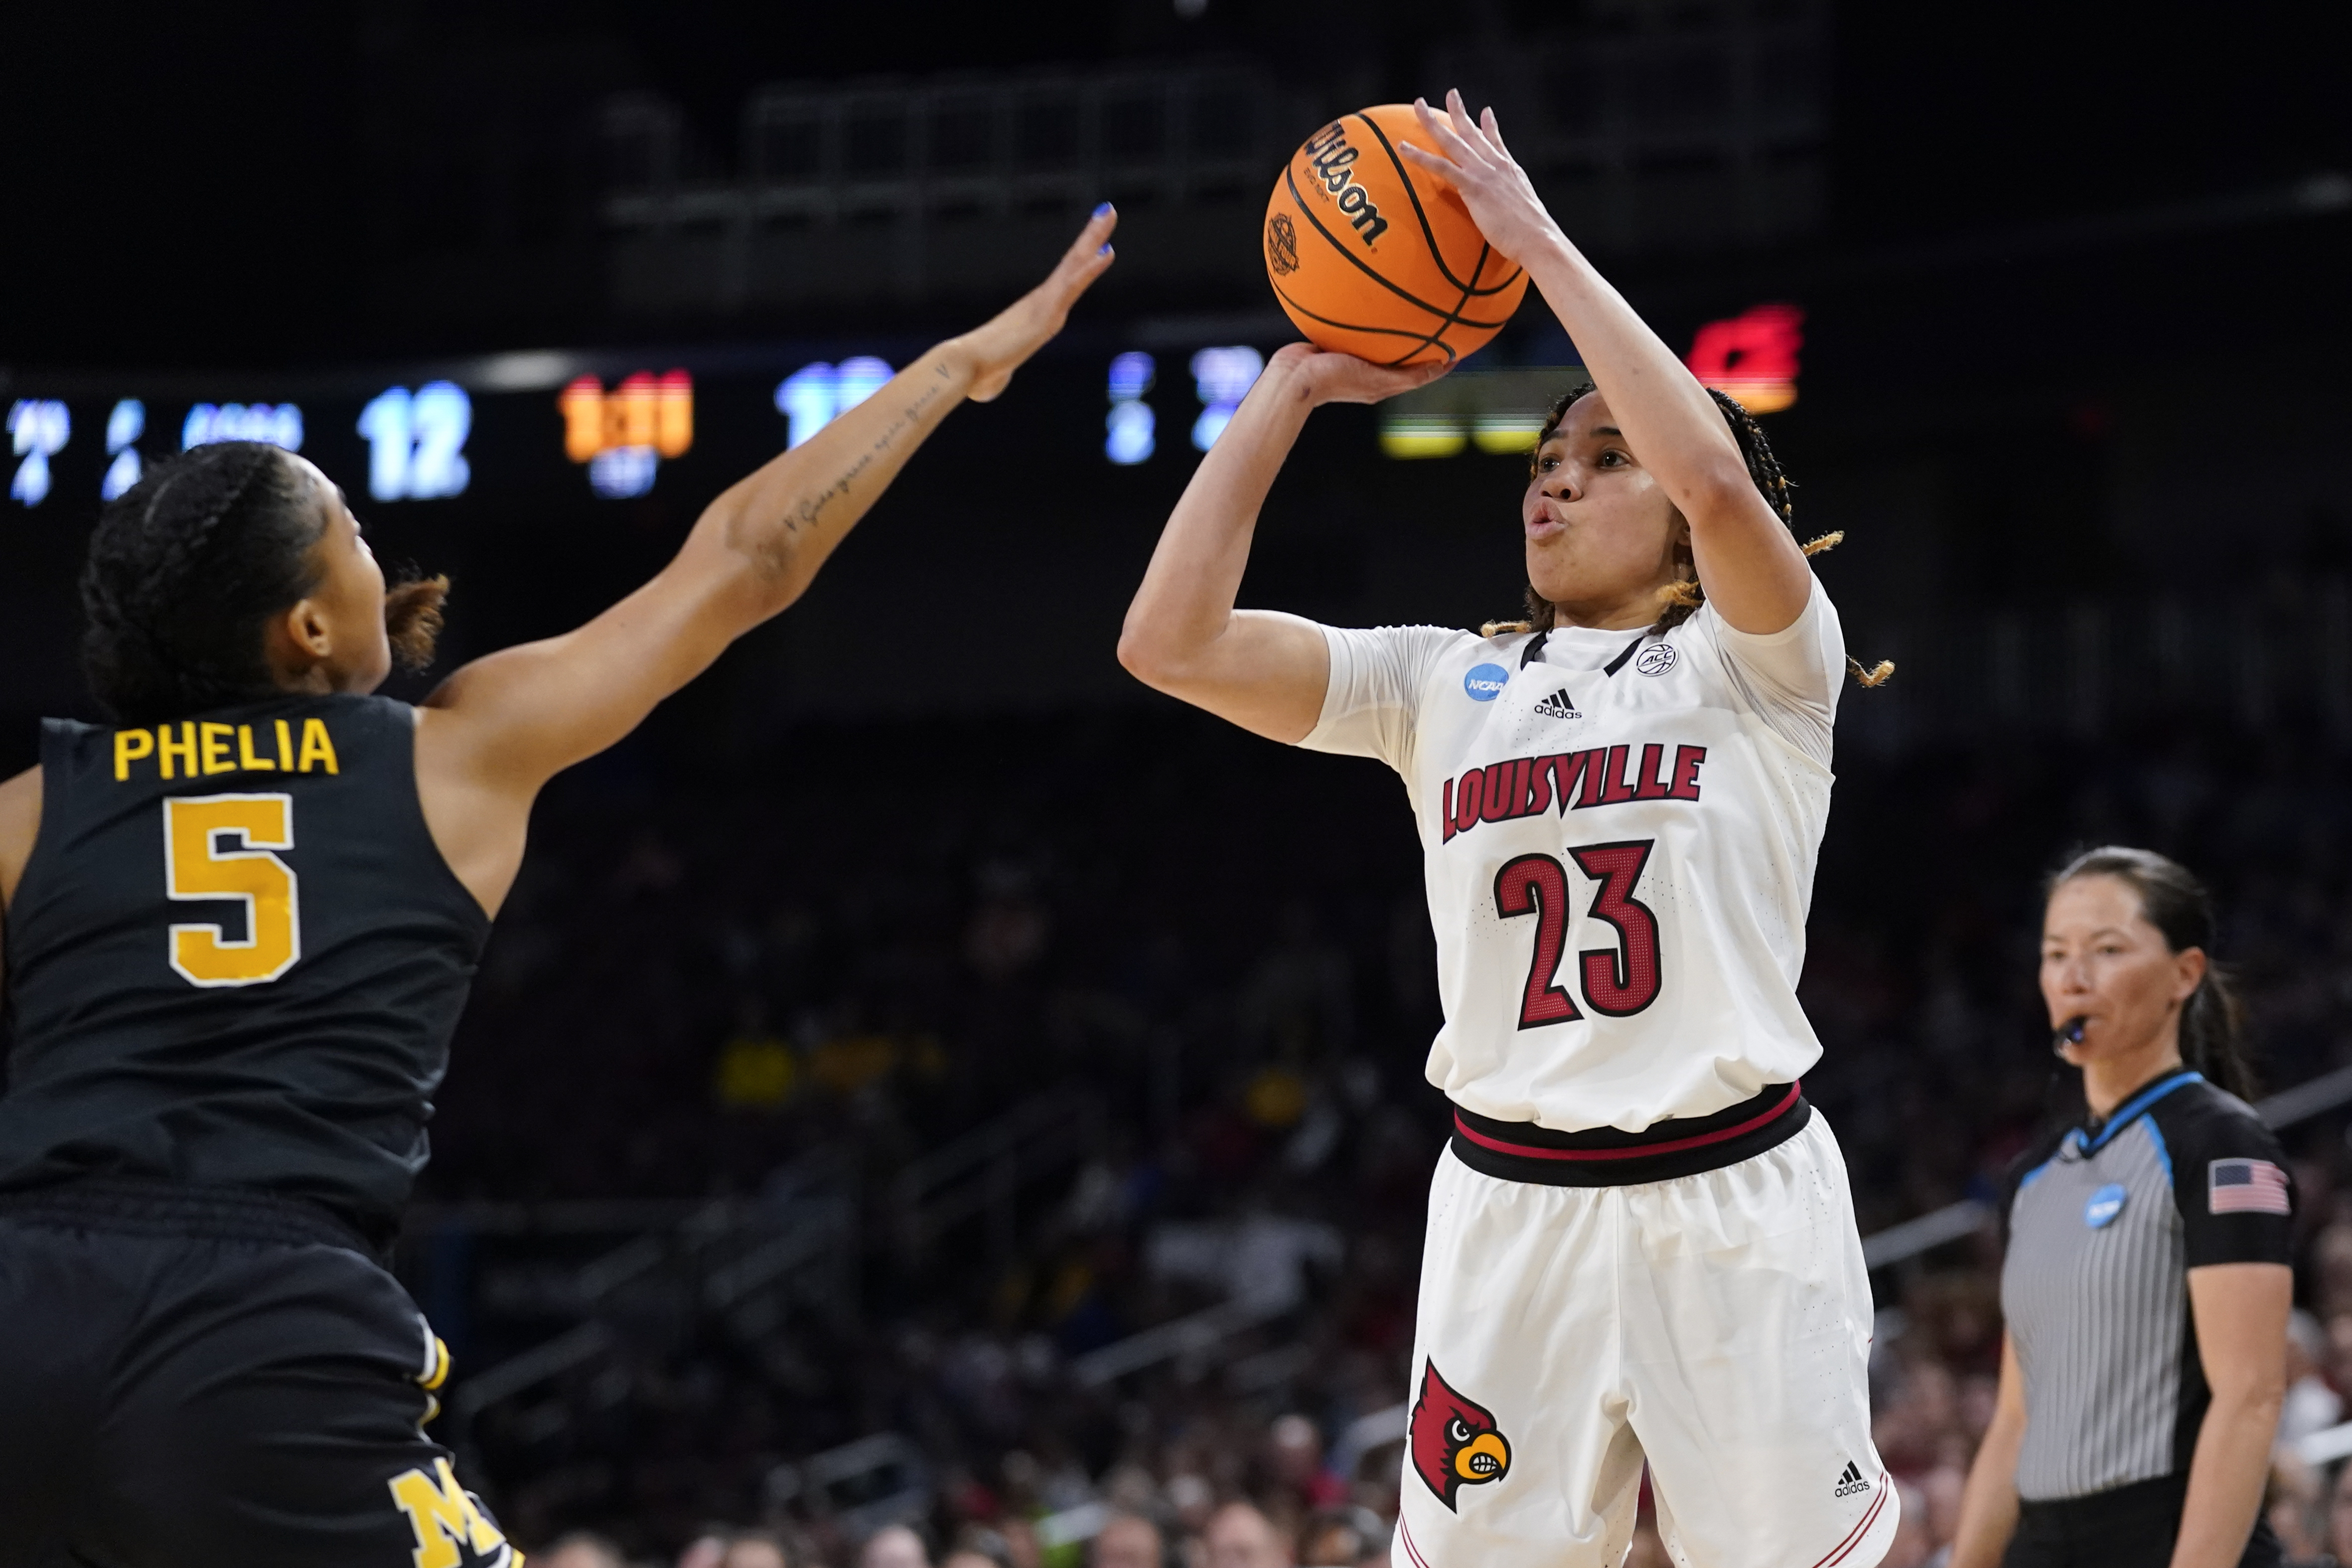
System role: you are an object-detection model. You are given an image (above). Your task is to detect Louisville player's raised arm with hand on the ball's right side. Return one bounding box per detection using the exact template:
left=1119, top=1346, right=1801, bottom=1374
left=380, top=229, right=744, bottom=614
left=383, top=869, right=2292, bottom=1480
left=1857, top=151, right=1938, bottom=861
left=1399, top=92, right=1813, bottom=635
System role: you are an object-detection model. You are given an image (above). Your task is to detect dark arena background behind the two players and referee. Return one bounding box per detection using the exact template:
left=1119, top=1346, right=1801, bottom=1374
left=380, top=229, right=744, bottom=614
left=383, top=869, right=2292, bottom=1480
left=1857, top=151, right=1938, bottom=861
left=0, top=0, right=2352, bottom=1568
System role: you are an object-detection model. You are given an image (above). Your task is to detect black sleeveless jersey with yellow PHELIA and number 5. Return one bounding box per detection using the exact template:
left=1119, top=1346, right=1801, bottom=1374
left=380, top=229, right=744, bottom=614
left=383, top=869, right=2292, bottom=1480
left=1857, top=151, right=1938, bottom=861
left=0, top=696, right=489, bottom=1236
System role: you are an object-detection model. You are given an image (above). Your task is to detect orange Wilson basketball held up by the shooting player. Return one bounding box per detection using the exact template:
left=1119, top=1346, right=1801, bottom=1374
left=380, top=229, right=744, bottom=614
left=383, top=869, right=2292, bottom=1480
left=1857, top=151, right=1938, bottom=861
left=1265, top=103, right=1527, bottom=364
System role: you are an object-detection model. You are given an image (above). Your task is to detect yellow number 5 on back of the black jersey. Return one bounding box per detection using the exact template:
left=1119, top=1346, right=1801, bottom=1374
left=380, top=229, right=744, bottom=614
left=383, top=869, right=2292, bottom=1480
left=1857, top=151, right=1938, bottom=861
left=162, top=795, right=301, bottom=987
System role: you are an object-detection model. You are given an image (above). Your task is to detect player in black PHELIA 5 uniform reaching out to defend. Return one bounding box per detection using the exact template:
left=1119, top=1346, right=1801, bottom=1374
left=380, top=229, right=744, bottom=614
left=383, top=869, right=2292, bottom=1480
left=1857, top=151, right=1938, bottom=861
left=0, top=207, right=1117, bottom=1568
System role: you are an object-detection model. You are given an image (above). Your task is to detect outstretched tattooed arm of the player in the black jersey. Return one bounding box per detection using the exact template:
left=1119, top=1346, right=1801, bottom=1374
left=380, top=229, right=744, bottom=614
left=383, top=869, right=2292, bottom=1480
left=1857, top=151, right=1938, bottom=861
left=416, top=207, right=1117, bottom=910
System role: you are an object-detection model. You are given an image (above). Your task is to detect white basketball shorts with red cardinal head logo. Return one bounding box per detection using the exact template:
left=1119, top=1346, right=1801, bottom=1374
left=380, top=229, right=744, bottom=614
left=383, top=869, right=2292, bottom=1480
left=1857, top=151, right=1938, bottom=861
left=1392, top=1114, right=1898, bottom=1568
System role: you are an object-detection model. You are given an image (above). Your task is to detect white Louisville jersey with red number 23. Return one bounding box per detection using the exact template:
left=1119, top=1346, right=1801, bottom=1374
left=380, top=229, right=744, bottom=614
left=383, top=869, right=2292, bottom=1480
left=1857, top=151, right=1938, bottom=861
left=1303, top=583, right=1844, bottom=1133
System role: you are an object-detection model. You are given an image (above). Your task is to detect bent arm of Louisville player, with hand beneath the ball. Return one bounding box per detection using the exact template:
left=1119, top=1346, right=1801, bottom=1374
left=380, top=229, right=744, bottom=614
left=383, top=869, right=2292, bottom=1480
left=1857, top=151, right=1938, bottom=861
left=1119, top=343, right=1444, bottom=743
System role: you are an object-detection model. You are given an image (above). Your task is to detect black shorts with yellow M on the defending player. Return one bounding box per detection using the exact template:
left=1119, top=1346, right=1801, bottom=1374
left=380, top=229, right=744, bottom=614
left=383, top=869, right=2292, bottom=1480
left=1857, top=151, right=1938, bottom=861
left=0, top=1180, right=520, bottom=1568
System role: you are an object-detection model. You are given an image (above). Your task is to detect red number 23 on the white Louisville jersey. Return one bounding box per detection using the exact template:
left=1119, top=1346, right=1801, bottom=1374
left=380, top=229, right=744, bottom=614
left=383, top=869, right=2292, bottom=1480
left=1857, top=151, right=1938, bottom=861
left=1494, top=839, right=1661, bottom=1030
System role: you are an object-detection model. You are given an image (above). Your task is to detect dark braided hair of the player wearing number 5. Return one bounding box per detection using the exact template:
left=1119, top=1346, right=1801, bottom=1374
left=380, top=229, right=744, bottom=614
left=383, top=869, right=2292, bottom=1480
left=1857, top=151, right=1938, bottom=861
left=82, top=442, right=449, bottom=724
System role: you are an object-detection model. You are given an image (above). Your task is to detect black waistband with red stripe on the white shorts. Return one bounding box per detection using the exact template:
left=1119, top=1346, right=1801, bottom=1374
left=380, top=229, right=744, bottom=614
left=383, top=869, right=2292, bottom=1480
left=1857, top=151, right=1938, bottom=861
left=1453, top=1084, right=1813, bottom=1187
